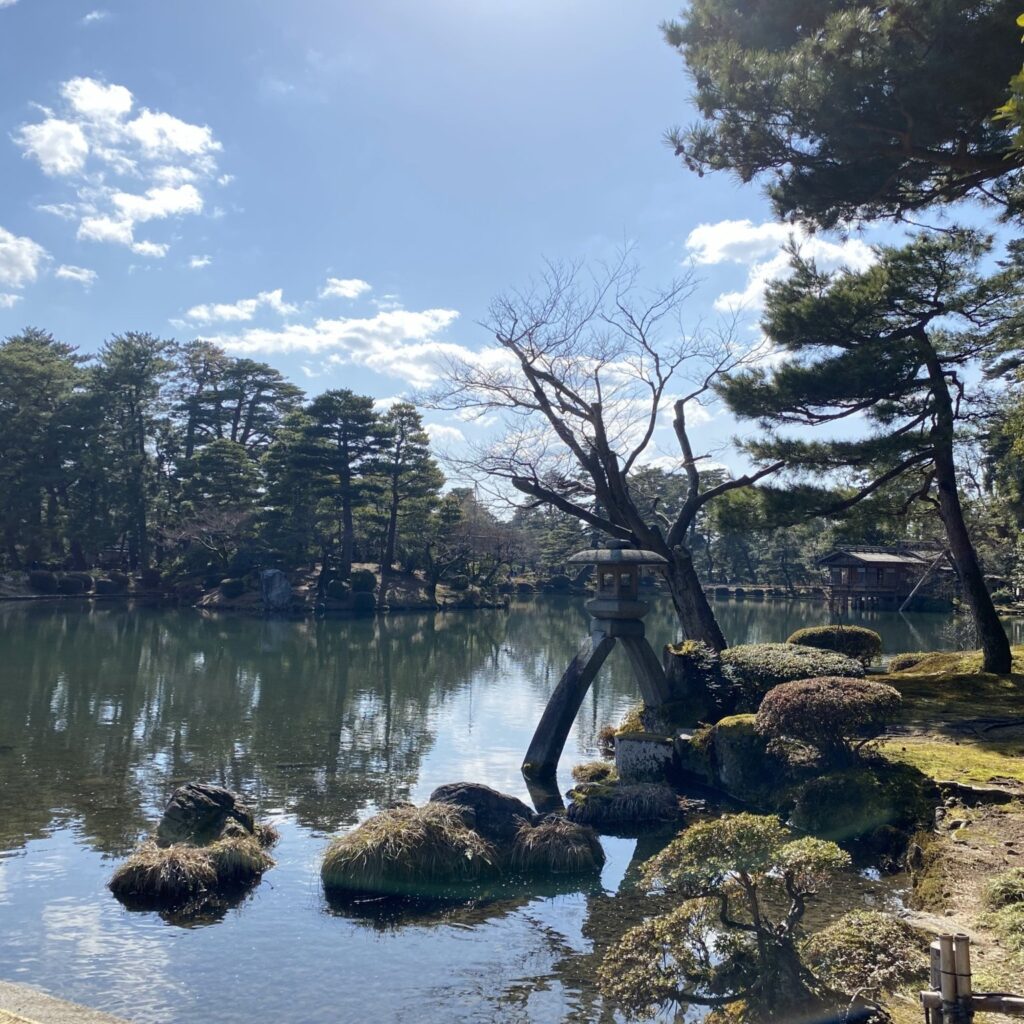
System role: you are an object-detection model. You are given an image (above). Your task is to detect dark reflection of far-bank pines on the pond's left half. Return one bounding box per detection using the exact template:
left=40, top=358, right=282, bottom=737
left=0, top=605, right=505, bottom=855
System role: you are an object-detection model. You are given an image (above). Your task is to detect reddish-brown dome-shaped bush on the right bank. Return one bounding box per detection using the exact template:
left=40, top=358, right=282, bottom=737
left=755, top=676, right=902, bottom=766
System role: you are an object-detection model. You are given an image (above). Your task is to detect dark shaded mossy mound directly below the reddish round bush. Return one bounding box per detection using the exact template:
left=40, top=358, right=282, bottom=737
left=792, top=760, right=938, bottom=847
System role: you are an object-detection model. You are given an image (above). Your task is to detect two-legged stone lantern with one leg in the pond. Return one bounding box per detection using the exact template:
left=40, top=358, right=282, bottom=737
left=522, top=541, right=669, bottom=779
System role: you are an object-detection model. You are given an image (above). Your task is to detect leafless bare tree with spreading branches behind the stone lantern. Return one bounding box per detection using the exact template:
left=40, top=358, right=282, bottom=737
left=427, top=251, right=781, bottom=650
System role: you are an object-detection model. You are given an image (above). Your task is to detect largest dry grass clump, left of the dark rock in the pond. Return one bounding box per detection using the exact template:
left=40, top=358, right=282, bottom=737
left=321, top=804, right=498, bottom=895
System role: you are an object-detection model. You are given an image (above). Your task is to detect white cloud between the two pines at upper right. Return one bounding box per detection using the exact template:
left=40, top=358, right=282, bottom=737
left=686, top=220, right=876, bottom=311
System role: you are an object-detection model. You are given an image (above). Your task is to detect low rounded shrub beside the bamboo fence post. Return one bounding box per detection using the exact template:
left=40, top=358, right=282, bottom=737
left=802, top=910, right=928, bottom=998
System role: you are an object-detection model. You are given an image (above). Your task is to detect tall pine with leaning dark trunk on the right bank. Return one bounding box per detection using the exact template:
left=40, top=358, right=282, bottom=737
left=720, top=231, right=1020, bottom=672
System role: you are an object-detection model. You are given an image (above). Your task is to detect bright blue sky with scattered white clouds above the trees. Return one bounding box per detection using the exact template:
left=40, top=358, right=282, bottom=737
left=0, top=0, right=870, bottom=468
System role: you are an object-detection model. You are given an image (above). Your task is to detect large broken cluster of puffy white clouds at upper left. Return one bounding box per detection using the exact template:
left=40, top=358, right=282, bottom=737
left=13, top=76, right=223, bottom=256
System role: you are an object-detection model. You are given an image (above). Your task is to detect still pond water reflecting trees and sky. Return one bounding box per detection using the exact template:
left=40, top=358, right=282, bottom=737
left=0, top=598, right=1007, bottom=1024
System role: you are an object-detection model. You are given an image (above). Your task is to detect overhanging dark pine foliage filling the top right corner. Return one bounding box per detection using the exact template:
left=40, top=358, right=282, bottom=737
left=665, top=0, right=1024, bottom=227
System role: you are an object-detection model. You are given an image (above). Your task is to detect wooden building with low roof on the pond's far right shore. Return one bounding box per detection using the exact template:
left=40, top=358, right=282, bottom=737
left=817, top=546, right=956, bottom=611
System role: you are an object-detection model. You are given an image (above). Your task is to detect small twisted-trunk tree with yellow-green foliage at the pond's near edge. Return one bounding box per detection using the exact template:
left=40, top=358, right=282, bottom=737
left=599, top=814, right=850, bottom=1021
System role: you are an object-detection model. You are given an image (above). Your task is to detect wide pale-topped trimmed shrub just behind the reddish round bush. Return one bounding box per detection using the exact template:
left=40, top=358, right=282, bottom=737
left=721, top=643, right=864, bottom=712
